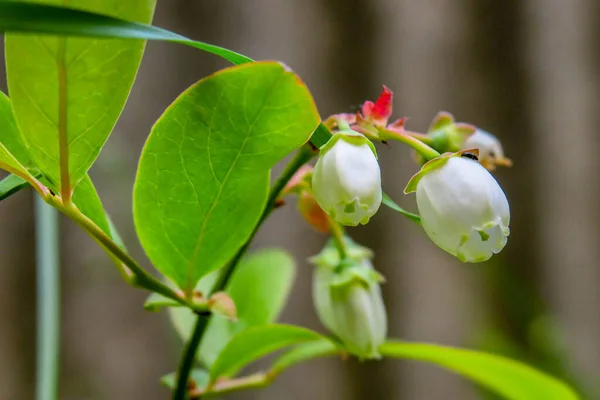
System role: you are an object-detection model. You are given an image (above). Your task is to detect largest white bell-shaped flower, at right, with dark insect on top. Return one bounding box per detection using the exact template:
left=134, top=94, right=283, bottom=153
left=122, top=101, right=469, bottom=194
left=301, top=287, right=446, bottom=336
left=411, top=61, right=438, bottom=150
left=406, top=154, right=510, bottom=263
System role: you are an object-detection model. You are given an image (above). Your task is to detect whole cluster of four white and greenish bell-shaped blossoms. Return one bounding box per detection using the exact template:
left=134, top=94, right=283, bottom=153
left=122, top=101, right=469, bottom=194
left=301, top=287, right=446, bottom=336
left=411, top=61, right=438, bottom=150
left=311, top=123, right=510, bottom=358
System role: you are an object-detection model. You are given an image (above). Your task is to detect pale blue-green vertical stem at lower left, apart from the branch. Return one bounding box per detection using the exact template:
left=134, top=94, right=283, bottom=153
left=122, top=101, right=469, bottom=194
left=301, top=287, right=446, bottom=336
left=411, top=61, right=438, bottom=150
left=35, top=195, right=60, bottom=400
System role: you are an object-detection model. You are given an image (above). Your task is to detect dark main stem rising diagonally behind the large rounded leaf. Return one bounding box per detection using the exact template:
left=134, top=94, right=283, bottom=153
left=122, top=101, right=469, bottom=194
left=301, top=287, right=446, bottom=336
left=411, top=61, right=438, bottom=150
left=173, top=144, right=316, bottom=400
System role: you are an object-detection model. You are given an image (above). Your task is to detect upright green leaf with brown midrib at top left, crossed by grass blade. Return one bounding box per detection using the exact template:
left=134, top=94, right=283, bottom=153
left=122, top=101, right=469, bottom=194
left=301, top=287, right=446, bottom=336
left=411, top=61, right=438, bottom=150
left=5, top=0, right=155, bottom=192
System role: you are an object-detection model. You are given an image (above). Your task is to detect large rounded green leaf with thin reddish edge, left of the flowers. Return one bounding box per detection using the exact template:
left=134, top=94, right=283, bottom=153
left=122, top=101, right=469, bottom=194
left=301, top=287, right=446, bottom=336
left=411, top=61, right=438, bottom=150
left=134, top=62, right=320, bottom=291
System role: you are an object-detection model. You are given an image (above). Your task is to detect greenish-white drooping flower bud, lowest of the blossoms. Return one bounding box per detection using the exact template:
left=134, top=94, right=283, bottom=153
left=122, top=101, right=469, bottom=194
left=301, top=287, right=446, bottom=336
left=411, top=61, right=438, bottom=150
left=311, top=239, right=387, bottom=358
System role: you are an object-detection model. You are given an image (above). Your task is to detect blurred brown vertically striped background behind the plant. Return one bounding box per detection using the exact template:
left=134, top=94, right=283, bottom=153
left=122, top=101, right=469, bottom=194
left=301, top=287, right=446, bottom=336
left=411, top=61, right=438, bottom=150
left=0, top=0, right=600, bottom=400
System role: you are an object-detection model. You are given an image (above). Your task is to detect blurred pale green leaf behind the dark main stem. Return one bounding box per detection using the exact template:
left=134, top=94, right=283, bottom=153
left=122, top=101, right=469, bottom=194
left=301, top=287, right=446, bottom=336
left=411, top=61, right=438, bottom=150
left=170, top=249, right=296, bottom=366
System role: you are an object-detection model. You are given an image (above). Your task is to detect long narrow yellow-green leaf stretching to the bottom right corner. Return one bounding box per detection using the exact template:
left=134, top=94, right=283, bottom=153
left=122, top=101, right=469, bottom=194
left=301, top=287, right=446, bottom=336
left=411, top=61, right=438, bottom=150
left=379, top=342, right=579, bottom=400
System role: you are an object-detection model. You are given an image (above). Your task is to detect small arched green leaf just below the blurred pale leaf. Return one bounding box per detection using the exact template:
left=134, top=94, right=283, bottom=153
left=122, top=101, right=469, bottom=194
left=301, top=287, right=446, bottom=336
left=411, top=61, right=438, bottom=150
left=210, top=324, right=323, bottom=382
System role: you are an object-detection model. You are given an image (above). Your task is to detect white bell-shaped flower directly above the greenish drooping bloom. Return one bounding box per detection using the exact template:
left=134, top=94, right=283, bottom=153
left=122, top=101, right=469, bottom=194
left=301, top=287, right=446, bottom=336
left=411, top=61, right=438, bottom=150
left=312, top=131, right=382, bottom=226
